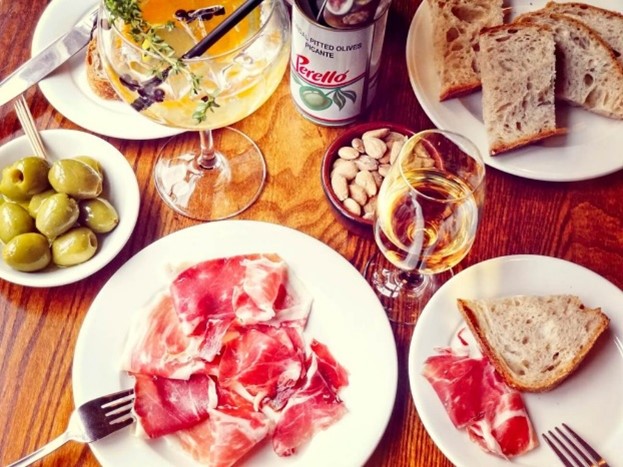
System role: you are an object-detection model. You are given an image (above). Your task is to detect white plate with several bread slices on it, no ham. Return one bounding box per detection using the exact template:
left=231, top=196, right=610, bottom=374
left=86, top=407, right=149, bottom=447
left=406, top=0, right=623, bottom=182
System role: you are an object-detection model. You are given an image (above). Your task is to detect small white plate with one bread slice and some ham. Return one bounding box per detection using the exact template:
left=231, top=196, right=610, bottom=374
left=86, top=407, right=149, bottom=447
left=409, top=255, right=623, bottom=467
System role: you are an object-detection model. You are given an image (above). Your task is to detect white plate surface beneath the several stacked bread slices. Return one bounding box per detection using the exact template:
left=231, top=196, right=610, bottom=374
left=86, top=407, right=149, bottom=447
left=406, top=0, right=623, bottom=182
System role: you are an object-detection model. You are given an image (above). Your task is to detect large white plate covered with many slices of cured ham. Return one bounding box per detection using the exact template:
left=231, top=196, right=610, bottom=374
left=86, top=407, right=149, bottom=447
left=73, top=220, right=397, bottom=467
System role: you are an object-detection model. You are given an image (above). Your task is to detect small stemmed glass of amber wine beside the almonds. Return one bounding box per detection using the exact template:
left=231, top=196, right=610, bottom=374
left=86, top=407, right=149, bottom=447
left=365, top=130, right=485, bottom=324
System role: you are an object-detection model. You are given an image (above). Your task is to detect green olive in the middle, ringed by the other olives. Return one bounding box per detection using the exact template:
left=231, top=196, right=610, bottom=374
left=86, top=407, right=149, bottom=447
left=35, top=193, right=80, bottom=240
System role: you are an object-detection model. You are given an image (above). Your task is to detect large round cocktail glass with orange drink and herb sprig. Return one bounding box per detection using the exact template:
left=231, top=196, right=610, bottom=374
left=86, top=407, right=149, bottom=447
left=97, top=0, right=290, bottom=221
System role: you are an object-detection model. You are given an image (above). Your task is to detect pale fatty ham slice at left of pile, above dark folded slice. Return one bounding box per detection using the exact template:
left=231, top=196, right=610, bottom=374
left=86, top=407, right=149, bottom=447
left=121, top=294, right=216, bottom=379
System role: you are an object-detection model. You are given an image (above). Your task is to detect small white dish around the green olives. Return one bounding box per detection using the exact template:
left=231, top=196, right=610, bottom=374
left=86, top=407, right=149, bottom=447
left=0, top=130, right=140, bottom=287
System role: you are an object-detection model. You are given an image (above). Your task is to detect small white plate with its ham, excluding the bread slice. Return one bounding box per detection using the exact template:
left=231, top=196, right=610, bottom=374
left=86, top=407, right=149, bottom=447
left=409, top=255, right=623, bottom=467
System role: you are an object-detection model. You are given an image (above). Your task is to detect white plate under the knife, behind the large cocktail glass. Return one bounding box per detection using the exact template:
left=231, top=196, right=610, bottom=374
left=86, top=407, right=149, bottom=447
left=32, top=0, right=183, bottom=140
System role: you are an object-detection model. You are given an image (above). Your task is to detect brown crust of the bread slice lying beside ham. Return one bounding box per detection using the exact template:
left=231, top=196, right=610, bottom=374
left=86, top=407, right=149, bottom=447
left=457, top=297, right=610, bottom=393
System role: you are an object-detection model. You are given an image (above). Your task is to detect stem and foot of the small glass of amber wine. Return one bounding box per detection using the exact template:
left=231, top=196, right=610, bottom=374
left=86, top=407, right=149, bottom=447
left=364, top=255, right=454, bottom=325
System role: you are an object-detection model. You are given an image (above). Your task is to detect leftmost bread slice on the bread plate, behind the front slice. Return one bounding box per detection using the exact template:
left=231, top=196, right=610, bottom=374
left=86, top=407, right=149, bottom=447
left=428, top=0, right=504, bottom=101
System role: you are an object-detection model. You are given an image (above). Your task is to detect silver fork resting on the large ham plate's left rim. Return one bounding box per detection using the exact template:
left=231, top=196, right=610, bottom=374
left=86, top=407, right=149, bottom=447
left=7, top=389, right=134, bottom=467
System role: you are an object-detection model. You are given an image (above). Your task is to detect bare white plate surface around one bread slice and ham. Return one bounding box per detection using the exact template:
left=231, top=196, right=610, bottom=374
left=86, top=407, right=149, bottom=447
left=409, top=255, right=623, bottom=467
